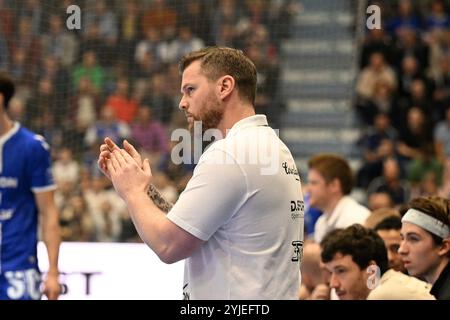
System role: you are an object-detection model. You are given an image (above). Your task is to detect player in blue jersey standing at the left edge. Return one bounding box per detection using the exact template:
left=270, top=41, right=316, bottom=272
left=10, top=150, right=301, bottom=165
left=0, top=73, right=61, bottom=300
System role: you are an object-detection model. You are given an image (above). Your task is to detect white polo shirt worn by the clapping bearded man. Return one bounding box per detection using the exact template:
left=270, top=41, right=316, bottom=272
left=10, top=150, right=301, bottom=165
left=167, top=115, right=303, bottom=300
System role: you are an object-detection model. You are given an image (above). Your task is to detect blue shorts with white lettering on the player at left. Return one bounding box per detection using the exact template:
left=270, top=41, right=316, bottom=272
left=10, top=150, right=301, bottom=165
left=0, top=269, right=42, bottom=300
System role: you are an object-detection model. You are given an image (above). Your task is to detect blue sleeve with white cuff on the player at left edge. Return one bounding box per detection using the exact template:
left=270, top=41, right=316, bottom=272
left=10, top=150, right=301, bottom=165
left=28, top=135, right=56, bottom=192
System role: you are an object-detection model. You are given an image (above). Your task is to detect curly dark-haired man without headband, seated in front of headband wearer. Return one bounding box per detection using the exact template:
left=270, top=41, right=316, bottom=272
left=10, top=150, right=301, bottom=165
left=321, top=224, right=434, bottom=300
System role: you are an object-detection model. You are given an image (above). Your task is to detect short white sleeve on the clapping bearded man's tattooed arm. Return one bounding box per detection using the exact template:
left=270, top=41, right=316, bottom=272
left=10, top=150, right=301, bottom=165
left=167, top=150, right=247, bottom=241
